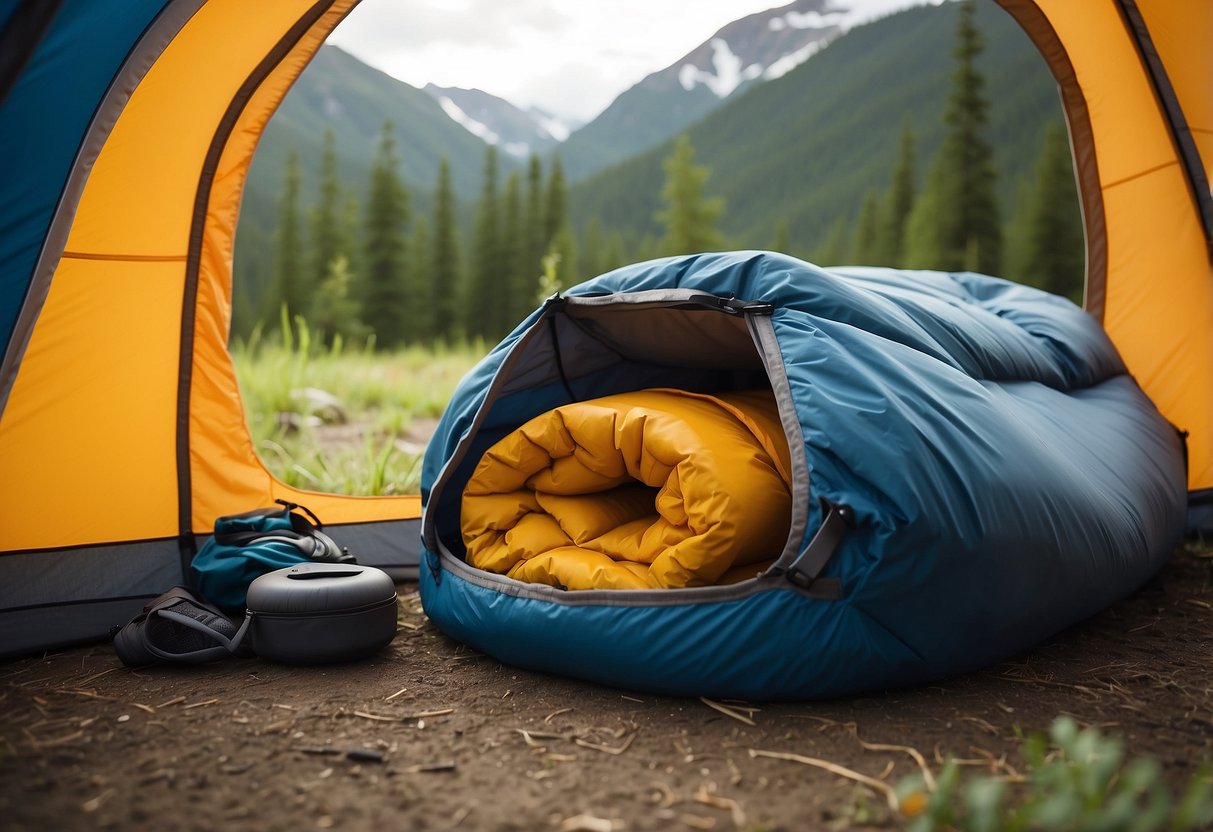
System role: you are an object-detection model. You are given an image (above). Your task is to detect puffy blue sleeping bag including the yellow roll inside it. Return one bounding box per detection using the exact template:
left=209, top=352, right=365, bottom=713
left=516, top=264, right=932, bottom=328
left=421, top=252, right=1186, bottom=699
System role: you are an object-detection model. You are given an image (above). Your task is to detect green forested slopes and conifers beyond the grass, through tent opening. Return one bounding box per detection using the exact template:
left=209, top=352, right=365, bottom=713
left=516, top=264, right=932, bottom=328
left=233, top=0, right=1083, bottom=346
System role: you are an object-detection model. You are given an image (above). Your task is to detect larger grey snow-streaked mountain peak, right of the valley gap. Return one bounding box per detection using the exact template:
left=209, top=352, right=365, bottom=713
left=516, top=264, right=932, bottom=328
left=560, top=0, right=853, bottom=178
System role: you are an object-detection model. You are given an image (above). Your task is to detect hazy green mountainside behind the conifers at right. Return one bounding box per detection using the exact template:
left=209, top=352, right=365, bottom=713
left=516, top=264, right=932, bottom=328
left=569, top=2, right=1061, bottom=255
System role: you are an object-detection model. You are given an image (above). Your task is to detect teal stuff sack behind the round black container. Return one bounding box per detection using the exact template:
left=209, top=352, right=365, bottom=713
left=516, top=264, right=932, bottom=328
left=190, top=500, right=354, bottom=610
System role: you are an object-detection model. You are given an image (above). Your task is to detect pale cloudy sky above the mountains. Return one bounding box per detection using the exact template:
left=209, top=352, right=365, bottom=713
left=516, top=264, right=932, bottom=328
left=329, top=0, right=927, bottom=119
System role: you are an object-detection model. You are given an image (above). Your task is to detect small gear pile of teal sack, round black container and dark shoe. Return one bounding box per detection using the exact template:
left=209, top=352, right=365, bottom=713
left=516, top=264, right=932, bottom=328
left=114, top=503, right=399, bottom=667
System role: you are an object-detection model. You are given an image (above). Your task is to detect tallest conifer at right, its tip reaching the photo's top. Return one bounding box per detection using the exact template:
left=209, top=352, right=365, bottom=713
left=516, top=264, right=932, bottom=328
left=906, top=0, right=1002, bottom=273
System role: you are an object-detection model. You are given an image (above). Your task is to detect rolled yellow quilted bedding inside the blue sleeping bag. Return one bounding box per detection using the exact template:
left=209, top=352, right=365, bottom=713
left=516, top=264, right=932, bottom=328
left=461, top=389, right=792, bottom=589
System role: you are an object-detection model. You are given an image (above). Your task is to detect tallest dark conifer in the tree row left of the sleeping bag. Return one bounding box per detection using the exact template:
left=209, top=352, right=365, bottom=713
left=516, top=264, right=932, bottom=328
left=360, top=124, right=417, bottom=348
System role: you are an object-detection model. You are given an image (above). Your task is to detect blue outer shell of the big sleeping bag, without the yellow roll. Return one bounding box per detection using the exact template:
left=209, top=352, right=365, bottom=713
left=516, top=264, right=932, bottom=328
left=421, top=252, right=1186, bottom=700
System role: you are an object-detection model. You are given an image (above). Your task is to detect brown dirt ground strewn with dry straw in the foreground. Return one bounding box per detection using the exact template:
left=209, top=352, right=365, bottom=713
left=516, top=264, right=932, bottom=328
left=0, top=540, right=1213, bottom=832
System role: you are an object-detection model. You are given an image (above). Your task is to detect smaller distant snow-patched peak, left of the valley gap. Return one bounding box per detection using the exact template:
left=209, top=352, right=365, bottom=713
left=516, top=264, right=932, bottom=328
left=425, top=84, right=579, bottom=159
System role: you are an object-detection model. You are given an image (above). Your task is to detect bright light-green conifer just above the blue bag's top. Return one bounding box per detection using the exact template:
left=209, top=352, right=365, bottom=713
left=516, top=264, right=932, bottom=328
left=656, top=133, right=724, bottom=255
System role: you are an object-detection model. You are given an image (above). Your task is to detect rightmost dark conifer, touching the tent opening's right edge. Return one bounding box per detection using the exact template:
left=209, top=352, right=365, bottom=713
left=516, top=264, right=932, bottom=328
left=1023, top=121, right=1086, bottom=301
